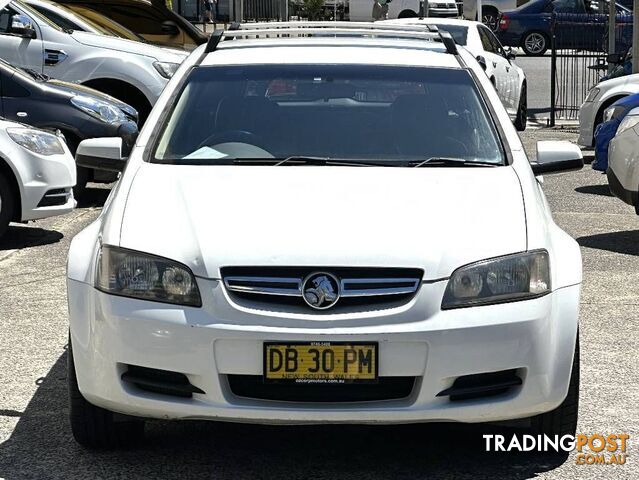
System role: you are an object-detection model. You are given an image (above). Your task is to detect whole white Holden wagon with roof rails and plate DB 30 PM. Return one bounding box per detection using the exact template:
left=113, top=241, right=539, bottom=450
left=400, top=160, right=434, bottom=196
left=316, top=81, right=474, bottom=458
left=68, top=22, right=583, bottom=447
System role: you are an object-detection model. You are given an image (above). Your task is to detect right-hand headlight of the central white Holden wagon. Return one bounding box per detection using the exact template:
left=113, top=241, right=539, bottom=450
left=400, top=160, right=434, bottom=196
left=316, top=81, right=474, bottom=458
left=442, top=250, right=550, bottom=310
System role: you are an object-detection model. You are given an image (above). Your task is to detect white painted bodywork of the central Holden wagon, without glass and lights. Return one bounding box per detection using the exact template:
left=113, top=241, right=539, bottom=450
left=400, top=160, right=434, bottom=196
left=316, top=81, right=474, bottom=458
left=68, top=34, right=582, bottom=423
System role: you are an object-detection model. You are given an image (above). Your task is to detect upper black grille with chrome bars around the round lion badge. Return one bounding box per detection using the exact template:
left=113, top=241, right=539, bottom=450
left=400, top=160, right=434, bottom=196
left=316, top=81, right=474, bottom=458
left=222, top=267, right=424, bottom=312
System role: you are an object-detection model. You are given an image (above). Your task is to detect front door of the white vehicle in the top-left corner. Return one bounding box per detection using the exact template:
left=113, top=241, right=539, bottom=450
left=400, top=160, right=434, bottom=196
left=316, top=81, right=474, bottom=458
left=0, top=4, right=43, bottom=72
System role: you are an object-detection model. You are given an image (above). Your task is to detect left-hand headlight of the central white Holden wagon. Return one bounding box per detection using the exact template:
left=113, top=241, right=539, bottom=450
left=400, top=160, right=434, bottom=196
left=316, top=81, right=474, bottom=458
left=95, top=245, right=202, bottom=307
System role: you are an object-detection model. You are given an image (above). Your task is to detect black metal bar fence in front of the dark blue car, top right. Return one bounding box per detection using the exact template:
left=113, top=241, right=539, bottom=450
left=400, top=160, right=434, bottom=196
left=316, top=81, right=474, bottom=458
left=550, top=13, right=632, bottom=125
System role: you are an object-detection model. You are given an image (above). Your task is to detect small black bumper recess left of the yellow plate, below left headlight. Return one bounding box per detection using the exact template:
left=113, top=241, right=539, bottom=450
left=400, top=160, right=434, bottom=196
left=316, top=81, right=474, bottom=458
left=121, top=365, right=204, bottom=398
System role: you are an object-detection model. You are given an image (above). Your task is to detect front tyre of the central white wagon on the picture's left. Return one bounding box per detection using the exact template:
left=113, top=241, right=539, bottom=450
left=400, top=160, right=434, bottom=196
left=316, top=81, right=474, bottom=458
left=67, top=339, right=144, bottom=449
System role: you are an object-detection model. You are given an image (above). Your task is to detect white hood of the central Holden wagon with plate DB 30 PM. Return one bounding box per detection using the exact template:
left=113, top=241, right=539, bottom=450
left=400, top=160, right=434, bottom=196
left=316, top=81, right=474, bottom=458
left=117, top=163, right=526, bottom=280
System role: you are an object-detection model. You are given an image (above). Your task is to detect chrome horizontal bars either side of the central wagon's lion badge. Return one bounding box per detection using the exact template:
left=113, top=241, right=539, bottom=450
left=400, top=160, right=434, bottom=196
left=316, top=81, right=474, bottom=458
left=224, top=275, right=421, bottom=297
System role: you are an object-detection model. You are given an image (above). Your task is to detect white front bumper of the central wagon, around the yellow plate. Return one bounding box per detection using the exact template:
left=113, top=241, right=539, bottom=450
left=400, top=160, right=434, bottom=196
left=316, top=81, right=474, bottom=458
left=68, top=280, right=580, bottom=424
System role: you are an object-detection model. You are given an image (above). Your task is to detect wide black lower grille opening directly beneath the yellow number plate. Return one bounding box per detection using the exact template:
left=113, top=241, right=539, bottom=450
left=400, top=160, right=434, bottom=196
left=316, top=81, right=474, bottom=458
left=227, top=375, right=415, bottom=403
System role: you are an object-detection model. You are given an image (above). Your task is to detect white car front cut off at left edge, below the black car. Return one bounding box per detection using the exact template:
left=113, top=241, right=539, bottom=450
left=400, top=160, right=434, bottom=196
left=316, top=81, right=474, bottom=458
left=0, top=118, right=76, bottom=237
